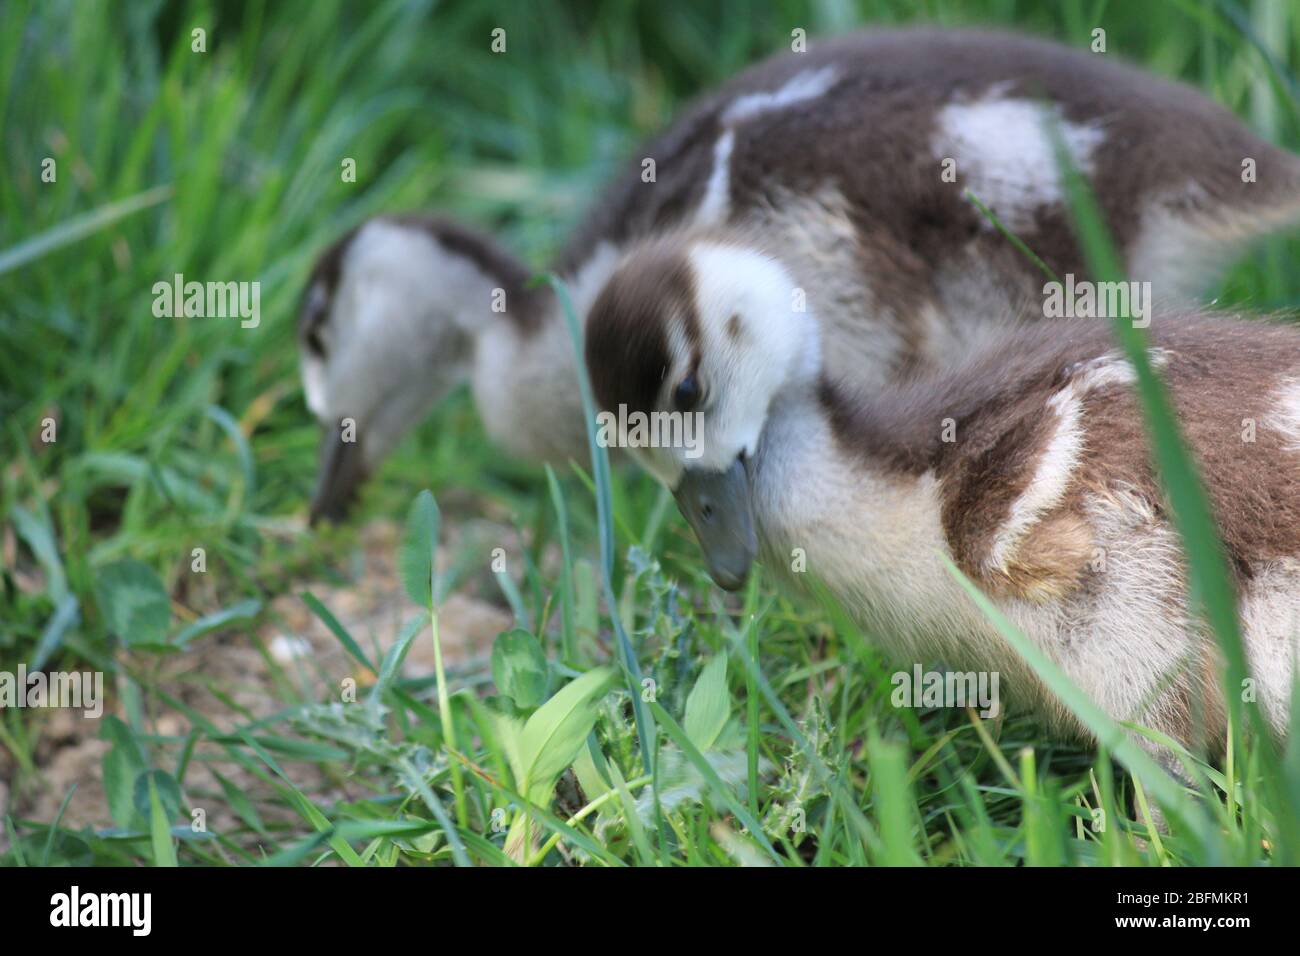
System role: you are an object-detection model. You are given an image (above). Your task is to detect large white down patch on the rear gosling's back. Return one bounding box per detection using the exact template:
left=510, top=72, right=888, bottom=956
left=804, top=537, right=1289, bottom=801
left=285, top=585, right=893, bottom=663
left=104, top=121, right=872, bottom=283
left=931, top=88, right=1106, bottom=232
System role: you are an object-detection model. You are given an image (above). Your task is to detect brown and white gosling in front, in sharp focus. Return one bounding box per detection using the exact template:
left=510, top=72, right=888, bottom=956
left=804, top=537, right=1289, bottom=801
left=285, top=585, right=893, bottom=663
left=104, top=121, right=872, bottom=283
left=586, top=243, right=1300, bottom=749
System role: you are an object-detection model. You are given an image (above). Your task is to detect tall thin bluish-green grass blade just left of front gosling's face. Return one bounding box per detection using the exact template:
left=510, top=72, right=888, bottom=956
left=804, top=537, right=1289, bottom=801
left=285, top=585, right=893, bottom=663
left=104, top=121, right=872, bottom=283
left=546, top=274, right=651, bottom=774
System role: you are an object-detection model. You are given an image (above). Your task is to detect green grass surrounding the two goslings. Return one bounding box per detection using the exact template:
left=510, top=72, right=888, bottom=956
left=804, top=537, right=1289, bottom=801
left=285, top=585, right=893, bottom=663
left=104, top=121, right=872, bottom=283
left=0, top=0, right=1300, bottom=866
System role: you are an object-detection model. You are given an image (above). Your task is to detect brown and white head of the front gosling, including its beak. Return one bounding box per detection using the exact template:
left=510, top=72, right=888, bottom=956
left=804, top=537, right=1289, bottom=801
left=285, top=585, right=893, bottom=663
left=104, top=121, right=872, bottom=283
left=586, top=239, right=819, bottom=589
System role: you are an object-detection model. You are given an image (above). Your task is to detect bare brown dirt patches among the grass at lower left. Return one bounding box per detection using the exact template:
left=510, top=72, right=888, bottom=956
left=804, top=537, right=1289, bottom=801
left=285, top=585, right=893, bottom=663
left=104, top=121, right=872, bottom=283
left=0, top=520, right=512, bottom=858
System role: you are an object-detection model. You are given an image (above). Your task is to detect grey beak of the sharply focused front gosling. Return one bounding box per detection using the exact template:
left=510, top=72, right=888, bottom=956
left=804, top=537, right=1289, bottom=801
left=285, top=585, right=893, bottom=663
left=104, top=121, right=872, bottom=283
left=673, top=458, right=758, bottom=591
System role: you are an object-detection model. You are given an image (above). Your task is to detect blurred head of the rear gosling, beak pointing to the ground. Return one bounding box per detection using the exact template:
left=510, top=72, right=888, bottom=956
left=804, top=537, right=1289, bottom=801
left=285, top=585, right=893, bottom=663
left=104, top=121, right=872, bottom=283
left=298, top=216, right=528, bottom=523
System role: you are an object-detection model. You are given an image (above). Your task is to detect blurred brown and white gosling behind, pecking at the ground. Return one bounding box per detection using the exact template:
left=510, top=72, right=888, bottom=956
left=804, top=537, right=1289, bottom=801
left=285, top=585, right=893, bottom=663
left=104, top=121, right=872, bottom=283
left=299, top=29, right=1300, bottom=516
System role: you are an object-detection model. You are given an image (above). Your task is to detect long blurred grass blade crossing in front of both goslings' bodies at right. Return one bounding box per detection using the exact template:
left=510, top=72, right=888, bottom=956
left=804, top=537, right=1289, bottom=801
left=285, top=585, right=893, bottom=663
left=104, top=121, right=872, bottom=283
left=1048, top=125, right=1300, bottom=862
